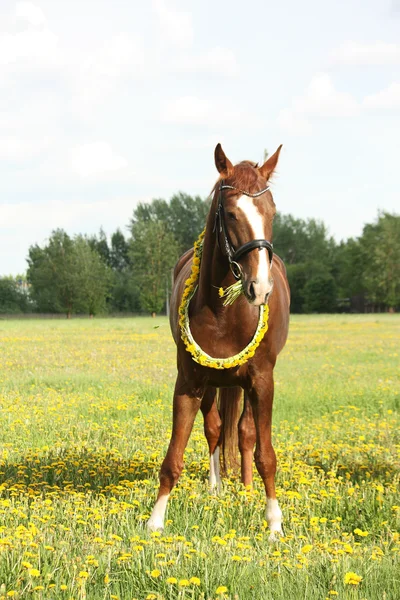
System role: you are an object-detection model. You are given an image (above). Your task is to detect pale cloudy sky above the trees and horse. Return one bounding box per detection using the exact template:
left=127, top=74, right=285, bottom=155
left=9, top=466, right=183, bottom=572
left=0, top=0, right=400, bottom=276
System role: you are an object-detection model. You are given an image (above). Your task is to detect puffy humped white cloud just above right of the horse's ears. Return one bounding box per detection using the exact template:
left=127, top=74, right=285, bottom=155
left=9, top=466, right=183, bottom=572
left=278, top=73, right=359, bottom=134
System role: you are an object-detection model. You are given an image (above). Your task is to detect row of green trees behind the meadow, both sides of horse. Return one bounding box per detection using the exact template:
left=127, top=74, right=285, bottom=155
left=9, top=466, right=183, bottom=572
left=0, top=193, right=400, bottom=316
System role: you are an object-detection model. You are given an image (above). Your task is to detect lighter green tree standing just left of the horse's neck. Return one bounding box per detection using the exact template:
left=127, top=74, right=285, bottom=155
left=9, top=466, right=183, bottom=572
left=129, top=220, right=178, bottom=313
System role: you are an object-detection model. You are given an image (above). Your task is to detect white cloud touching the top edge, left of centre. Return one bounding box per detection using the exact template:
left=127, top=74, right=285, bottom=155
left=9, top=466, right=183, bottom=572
left=152, top=0, right=194, bottom=48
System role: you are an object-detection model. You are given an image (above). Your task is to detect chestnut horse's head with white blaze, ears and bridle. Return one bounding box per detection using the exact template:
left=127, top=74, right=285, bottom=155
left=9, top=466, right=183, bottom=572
left=215, top=144, right=282, bottom=306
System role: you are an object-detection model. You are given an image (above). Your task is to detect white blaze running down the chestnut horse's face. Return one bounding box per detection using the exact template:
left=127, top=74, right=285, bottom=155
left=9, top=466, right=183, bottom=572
left=237, top=196, right=272, bottom=298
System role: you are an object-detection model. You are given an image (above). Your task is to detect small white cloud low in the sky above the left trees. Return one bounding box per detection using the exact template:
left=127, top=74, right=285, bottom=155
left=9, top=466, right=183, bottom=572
left=70, top=141, right=128, bottom=177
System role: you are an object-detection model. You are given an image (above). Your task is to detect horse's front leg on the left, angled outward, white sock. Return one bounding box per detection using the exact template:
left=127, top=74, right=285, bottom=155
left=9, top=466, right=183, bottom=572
left=147, top=374, right=204, bottom=531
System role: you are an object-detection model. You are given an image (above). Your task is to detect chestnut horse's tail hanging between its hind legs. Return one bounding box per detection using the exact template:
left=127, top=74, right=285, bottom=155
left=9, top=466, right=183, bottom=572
left=218, top=387, right=243, bottom=474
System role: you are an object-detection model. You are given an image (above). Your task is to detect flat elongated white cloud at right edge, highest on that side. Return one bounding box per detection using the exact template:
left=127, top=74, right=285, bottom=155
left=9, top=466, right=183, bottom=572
left=331, top=42, right=400, bottom=66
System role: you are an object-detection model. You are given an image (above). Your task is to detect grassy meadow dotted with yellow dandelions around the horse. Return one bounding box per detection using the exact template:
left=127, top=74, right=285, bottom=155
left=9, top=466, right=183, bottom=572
left=0, top=315, right=400, bottom=600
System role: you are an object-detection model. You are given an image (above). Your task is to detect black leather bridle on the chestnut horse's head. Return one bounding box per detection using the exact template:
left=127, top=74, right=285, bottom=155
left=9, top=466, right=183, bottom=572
left=214, top=179, right=274, bottom=279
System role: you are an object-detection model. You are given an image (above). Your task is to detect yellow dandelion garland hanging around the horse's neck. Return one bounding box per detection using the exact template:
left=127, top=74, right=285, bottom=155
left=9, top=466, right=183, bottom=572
left=179, top=229, right=269, bottom=369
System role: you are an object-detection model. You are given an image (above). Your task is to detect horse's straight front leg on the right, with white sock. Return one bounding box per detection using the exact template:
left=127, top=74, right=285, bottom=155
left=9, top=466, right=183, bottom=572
left=249, top=365, right=283, bottom=540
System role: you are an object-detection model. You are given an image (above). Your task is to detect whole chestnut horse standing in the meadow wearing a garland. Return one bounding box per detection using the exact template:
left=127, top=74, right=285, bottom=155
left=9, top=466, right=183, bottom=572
left=147, top=144, right=290, bottom=539
